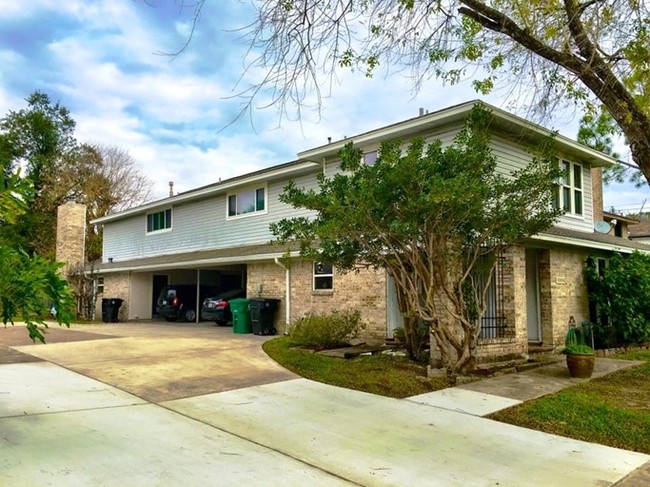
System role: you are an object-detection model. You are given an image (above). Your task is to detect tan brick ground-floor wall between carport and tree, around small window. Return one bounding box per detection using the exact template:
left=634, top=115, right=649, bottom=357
left=246, top=259, right=386, bottom=337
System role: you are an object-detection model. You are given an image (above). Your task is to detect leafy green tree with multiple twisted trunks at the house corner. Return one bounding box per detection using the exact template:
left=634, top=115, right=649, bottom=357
left=272, top=107, right=561, bottom=377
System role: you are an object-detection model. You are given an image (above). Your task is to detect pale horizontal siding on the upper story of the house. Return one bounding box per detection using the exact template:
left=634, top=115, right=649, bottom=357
left=103, top=125, right=593, bottom=262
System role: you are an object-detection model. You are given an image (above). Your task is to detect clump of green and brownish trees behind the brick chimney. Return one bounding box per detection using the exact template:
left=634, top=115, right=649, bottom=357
left=0, top=91, right=151, bottom=261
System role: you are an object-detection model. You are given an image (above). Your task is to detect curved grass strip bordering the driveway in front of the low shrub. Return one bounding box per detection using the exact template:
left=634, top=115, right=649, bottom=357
left=263, top=337, right=447, bottom=398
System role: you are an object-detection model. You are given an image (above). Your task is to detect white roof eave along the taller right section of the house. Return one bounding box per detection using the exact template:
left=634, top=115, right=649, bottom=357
left=298, top=100, right=617, bottom=167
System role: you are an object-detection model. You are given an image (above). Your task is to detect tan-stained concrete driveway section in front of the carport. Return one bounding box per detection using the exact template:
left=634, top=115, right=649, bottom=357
left=0, top=322, right=296, bottom=402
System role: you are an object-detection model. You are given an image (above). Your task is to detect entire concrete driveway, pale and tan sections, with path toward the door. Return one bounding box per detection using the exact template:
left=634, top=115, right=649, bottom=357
left=0, top=324, right=650, bottom=486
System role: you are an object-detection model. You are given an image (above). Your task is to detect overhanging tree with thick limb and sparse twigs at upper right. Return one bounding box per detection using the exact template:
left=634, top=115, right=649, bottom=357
left=182, top=0, right=650, bottom=185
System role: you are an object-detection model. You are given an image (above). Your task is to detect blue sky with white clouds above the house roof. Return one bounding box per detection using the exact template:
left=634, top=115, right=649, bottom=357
left=0, top=0, right=650, bottom=209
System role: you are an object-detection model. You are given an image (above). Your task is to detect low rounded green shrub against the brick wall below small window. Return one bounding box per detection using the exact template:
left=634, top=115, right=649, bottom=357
left=289, top=310, right=365, bottom=350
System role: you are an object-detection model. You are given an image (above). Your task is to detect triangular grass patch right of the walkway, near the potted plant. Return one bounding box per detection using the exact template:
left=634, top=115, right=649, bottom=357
left=489, top=350, right=650, bottom=454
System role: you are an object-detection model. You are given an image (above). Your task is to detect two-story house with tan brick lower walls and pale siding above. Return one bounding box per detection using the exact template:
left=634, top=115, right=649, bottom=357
left=83, top=102, right=650, bottom=366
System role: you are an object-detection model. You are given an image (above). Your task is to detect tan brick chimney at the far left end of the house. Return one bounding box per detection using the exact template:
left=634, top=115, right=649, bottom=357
left=56, top=203, right=86, bottom=276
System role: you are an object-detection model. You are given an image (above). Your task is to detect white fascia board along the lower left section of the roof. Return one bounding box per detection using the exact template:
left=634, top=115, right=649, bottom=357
left=90, top=161, right=317, bottom=225
